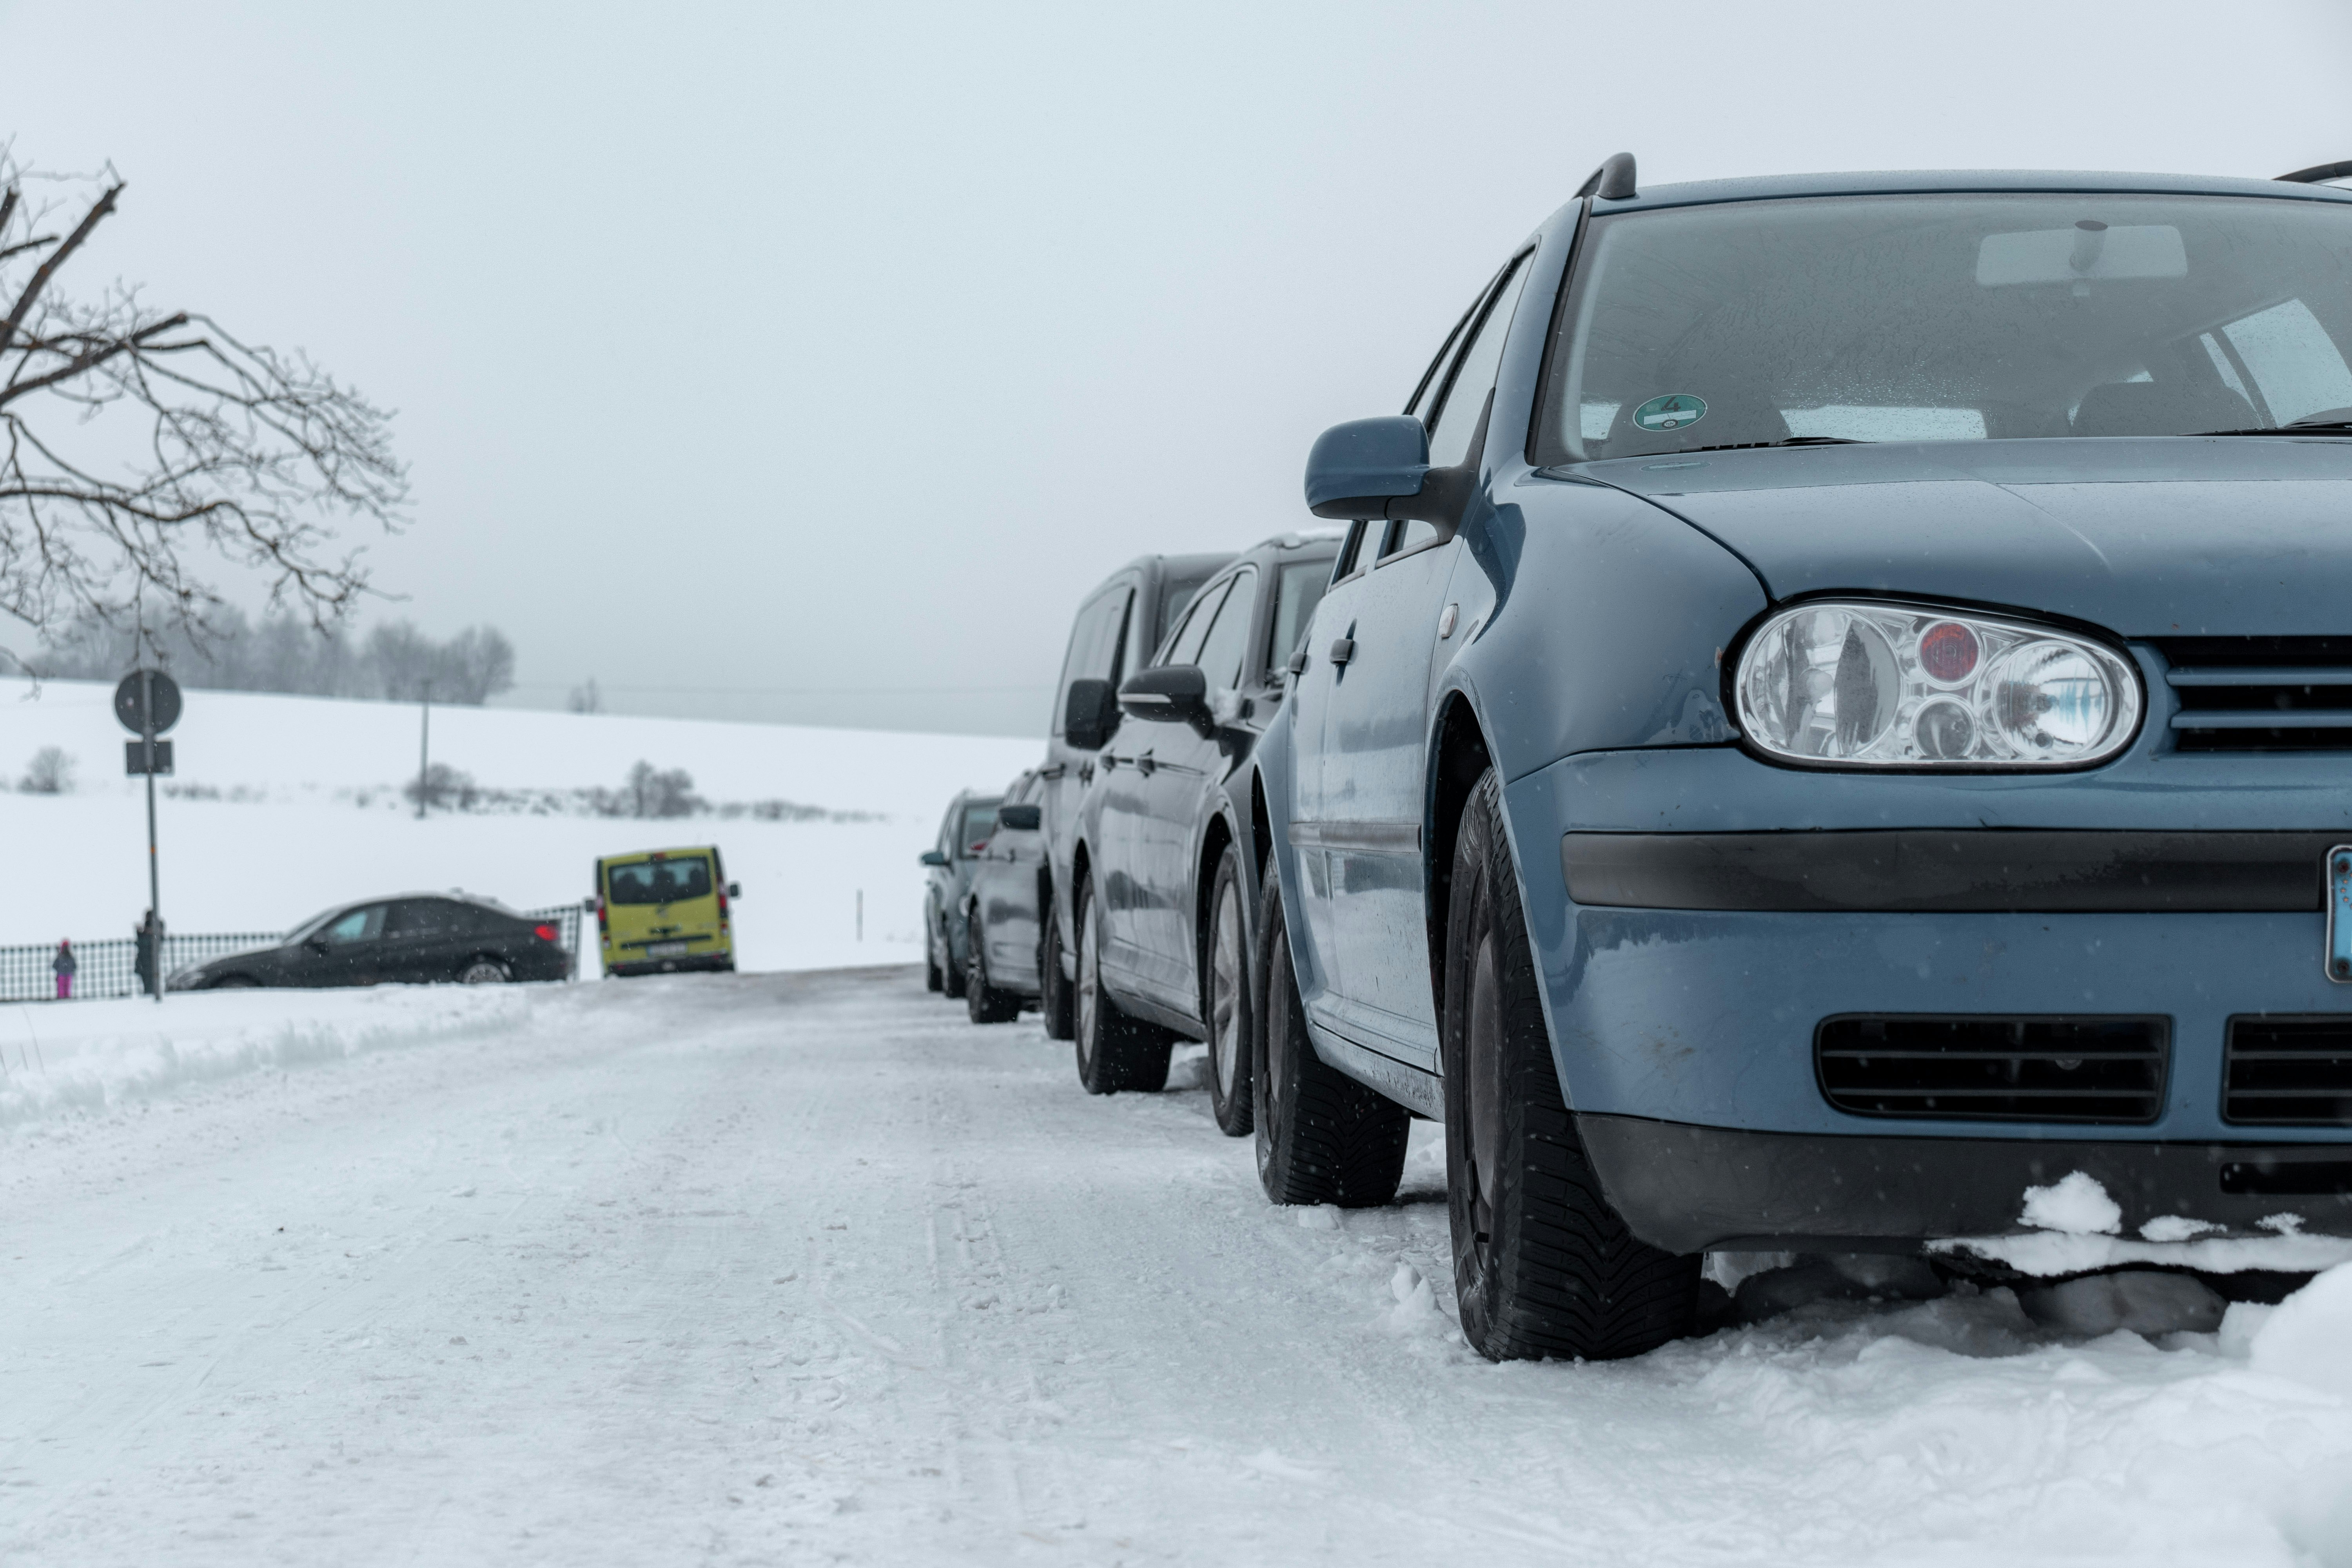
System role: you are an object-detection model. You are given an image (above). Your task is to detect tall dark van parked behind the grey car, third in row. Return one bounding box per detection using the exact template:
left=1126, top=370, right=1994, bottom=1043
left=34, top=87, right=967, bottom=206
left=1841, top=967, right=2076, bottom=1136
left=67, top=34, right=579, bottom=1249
left=1037, top=555, right=1232, bottom=1039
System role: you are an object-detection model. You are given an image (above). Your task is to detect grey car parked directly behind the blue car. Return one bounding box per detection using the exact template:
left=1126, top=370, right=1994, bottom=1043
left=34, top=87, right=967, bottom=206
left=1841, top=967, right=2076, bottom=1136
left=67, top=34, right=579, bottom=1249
left=1063, top=531, right=1338, bottom=1114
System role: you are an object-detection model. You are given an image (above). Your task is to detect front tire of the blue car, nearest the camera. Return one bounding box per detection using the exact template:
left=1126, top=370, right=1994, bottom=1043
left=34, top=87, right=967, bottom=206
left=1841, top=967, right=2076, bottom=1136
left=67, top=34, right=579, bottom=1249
left=1439, top=769, right=1703, bottom=1361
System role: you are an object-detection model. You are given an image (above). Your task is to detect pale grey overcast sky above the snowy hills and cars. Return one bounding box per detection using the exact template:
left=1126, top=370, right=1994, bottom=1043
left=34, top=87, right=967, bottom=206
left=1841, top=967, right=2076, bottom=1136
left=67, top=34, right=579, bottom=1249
left=0, top=0, right=2352, bottom=733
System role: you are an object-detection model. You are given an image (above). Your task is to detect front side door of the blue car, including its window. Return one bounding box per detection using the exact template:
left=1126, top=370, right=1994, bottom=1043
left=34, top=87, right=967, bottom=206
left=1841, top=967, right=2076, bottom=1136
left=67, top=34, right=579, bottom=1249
left=1294, top=251, right=1524, bottom=1072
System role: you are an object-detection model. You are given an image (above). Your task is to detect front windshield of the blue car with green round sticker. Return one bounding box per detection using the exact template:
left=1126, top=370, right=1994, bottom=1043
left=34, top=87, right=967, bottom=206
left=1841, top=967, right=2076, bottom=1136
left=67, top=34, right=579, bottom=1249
left=1536, top=195, right=2352, bottom=463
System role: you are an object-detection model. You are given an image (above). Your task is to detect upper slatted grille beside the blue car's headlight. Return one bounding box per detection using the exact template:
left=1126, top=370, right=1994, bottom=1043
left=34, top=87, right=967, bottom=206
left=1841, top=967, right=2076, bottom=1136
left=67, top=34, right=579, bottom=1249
left=2157, top=637, right=2352, bottom=752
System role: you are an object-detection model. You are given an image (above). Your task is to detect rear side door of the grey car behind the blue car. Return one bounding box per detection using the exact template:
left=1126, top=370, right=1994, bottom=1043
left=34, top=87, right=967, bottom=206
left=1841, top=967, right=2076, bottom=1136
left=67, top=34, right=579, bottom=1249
left=1094, top=578, right=1230, bottom=1002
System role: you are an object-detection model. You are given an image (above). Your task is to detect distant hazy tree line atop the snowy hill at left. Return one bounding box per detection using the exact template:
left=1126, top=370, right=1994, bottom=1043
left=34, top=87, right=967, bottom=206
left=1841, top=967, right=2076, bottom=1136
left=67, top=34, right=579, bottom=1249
left=26, top=606, right=515, bottom=708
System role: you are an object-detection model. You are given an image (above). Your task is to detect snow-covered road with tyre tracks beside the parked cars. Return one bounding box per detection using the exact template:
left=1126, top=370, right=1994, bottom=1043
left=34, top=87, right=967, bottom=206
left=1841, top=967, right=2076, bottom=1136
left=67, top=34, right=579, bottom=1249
left=0, top=971, right=2352, bottom=1563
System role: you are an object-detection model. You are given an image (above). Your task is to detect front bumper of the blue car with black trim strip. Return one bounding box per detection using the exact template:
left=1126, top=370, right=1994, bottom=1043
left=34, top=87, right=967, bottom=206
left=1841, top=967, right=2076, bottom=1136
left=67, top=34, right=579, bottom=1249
left=1505, top=748, right=2352, bottom=1250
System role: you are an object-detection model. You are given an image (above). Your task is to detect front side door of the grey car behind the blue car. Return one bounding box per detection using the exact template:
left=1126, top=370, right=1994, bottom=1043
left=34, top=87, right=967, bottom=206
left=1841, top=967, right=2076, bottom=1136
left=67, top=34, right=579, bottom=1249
left=1136, top=566, right=1258, bottom=1016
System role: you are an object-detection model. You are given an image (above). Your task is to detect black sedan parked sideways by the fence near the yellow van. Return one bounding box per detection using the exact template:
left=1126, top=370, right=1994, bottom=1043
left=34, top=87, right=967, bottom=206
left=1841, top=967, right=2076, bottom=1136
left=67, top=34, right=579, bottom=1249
left=169, top=893, right=574, bottom=990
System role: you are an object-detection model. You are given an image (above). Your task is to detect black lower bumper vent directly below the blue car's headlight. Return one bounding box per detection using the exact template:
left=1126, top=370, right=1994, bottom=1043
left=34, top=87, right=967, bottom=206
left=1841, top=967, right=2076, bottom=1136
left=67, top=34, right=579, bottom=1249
left=1813, top=1013, right=2171, bottom=1122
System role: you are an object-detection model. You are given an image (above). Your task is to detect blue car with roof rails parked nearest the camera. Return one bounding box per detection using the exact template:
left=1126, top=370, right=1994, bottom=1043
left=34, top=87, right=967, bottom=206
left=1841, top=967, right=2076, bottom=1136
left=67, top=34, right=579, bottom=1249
left=1251, top=155, right=2352, bottom=1359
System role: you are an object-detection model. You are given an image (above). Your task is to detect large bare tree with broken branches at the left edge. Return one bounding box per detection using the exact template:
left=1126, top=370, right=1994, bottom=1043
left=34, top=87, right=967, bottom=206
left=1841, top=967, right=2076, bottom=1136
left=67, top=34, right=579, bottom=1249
left=0, top=146, right=407, bottom=653
